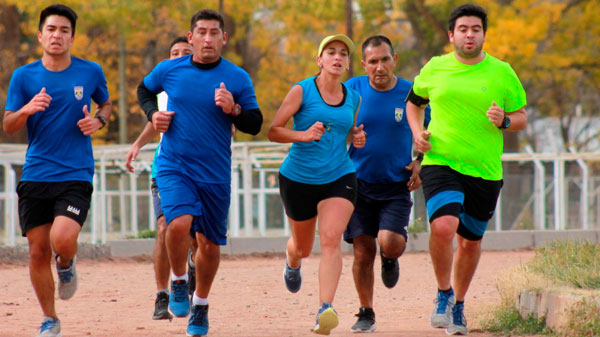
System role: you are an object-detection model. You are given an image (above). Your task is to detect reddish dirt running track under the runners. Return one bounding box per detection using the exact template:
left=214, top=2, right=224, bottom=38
left=0, top=251, right=534, bottom=337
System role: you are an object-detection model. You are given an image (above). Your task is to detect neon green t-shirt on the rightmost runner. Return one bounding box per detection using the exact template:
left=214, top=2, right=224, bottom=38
left=413, top=53, right=527, bottom=180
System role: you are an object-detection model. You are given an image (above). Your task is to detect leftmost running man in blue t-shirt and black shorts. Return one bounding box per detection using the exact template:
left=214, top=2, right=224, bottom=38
left=3, top=5, right=112, bottom=336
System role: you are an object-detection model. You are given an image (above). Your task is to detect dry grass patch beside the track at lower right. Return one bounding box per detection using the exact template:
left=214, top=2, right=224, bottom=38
left=480, top=240, right=600, bottom=337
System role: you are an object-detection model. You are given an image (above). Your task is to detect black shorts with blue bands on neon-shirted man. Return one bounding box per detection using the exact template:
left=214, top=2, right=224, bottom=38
left=421, top=165, right=503, bottom=241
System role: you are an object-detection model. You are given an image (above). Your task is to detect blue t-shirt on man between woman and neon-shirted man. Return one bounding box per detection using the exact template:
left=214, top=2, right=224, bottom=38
left=346, top=76, right=429, bottom=183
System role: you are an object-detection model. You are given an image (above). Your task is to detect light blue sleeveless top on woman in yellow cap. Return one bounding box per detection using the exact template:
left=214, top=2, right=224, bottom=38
left=279, top=76, right=360, bottom=185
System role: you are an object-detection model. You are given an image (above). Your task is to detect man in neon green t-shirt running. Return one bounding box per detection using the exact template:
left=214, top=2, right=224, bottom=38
left=406, top=4, right=527, bottom=335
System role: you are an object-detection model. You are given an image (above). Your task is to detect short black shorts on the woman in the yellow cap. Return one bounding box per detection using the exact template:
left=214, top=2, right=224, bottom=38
left=279, top=173, right=356, bottom=221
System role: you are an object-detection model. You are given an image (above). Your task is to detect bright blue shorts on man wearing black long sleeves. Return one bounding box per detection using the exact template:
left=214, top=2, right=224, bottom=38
left=156, top=171, right=231, bottom=245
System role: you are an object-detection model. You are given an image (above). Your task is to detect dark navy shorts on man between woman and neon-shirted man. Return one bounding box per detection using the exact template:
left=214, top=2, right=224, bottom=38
left=344, top=179, right=412, bottom=243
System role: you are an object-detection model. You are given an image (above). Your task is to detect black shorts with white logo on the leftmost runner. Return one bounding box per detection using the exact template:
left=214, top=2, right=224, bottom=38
left=17, top=181, right=94, bottom=236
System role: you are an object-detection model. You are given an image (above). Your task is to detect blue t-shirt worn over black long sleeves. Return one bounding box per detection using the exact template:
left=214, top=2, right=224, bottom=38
left=144, top=55, right=258, bottom=184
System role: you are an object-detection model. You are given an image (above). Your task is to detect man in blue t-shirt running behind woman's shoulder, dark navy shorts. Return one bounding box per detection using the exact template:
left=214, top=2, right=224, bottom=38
left=344, top=35, right=421, bottom=332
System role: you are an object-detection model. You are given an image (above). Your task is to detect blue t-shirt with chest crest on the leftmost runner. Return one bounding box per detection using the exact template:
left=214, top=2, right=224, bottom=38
left=6, top=56, right=109, bottom=183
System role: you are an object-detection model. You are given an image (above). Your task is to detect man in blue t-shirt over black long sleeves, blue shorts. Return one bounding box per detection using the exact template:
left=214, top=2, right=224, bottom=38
left=138, top=10, right=262, bottom=336
